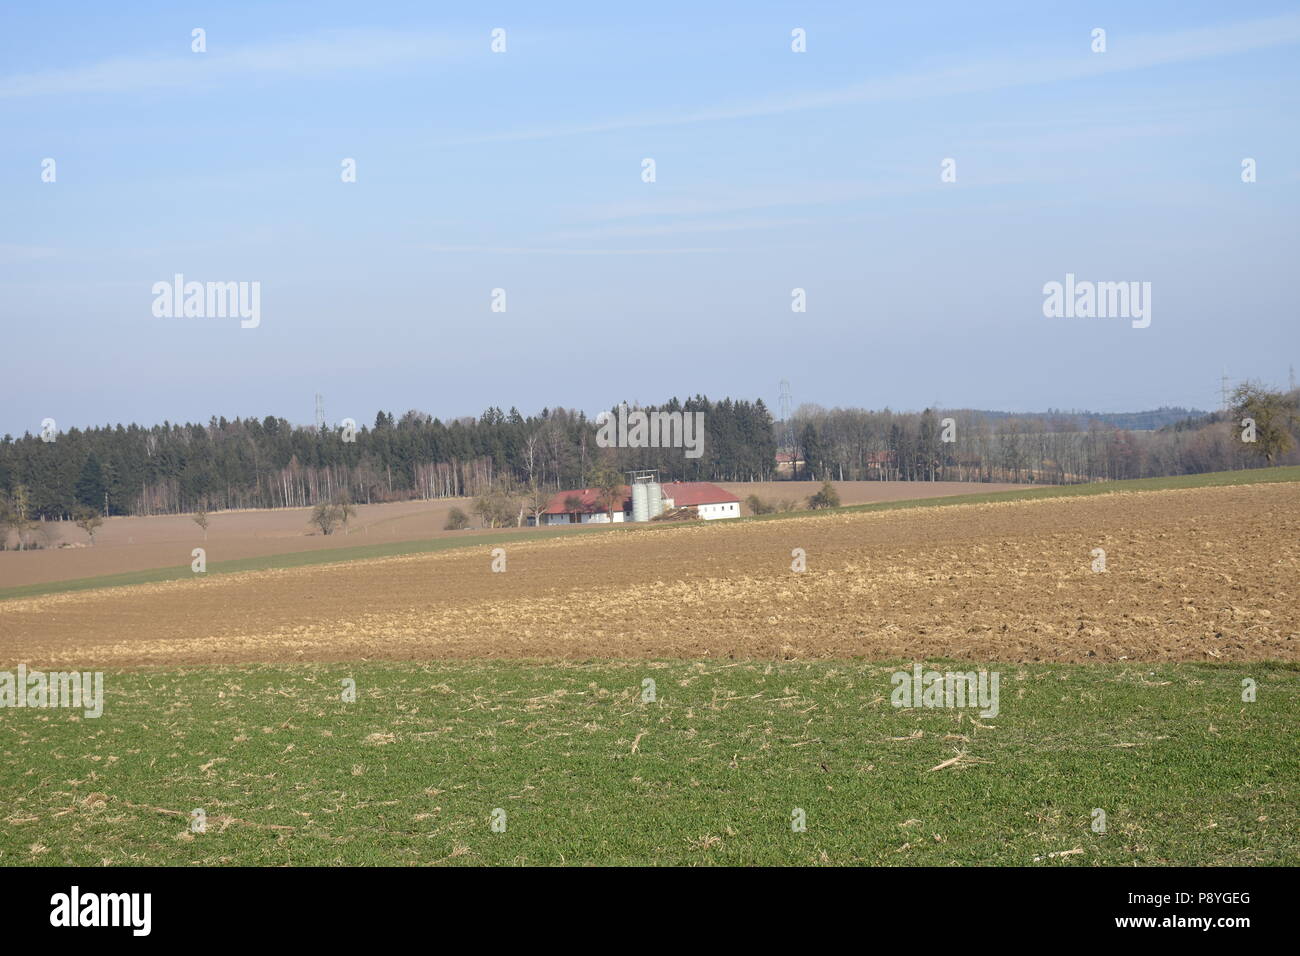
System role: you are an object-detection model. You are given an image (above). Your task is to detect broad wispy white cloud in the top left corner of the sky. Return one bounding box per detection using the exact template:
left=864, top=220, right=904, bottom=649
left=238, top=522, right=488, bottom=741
left=0, top=30, right=465, bottom=99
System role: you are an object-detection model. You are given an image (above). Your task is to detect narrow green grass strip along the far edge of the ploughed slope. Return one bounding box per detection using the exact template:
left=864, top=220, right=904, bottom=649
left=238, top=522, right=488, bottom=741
left=0, top=467, right=1300, bottom=601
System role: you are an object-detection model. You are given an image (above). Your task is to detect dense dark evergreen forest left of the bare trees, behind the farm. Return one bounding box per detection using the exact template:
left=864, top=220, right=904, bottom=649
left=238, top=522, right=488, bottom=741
left=0, top=395, right=775, bottom=520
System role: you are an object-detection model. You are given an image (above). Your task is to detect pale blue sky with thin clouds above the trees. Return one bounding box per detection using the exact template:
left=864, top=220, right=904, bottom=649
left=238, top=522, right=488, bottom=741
left=0, top=0, right=1300, bottom=434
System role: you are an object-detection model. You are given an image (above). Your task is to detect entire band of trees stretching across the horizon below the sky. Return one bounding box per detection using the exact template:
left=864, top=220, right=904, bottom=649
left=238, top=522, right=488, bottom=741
left=0, top=384, right=1300, bottom=546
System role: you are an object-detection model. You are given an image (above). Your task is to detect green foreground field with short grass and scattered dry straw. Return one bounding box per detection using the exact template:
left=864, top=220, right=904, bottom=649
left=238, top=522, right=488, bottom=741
left=0, top=661, right=1300, bottom=866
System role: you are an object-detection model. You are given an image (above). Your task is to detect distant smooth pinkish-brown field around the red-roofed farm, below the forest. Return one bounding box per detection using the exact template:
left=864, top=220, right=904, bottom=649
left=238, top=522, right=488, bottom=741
left=0, top=481, right=1022, bottom=588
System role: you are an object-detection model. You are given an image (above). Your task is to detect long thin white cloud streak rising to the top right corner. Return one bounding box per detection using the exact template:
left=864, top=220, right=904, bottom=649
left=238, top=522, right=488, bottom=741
left=454, top=14, right=1300, bottom=144
